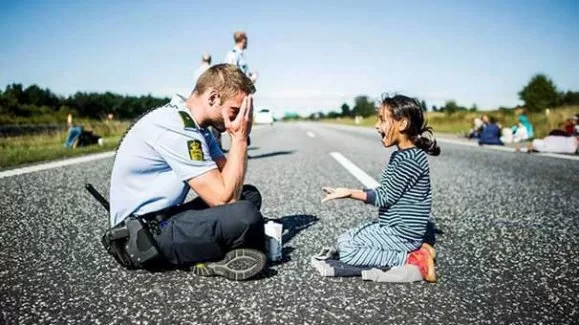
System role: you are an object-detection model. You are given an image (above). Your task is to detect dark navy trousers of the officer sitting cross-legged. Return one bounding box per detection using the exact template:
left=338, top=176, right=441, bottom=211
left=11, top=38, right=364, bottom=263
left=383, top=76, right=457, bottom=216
left=156, top=185, right=264, bottom=266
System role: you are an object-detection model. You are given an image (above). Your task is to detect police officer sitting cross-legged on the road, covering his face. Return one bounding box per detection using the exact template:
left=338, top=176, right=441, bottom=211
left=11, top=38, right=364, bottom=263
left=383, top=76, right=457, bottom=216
left=110, top=64, right=266, bottom=280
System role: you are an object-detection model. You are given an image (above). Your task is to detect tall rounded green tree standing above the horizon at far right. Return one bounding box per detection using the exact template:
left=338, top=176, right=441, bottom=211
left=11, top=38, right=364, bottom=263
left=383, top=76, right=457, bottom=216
left=519, top=74, right=559, bottom=112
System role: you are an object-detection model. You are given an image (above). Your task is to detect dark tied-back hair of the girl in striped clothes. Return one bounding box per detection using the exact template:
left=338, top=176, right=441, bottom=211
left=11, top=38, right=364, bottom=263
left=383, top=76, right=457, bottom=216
left=381, top=95, right=440, bottom=156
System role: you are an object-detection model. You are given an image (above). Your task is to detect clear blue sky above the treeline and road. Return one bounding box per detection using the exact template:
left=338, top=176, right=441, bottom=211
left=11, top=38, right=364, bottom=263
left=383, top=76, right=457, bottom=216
left=0, top=0, right=579, bottom=114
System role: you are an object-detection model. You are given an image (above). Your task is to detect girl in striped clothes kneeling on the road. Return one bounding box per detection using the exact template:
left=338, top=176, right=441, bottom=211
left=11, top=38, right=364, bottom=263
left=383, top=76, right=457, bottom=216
left=322, top=95, right=440, bottom=282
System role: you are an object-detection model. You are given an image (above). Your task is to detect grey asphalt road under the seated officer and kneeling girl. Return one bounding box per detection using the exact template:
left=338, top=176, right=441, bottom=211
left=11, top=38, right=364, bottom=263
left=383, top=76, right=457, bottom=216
left=0, top=123, right=579, bottom=324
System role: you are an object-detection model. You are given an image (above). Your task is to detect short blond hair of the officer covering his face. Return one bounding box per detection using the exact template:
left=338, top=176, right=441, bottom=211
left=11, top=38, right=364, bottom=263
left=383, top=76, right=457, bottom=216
left=193, top=64, right=255, bottom=101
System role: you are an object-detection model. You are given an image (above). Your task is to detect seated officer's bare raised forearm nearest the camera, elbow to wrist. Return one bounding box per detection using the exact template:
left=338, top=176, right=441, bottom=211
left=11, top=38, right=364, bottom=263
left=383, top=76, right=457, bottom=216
left=221, top=138, right=247, bottom=202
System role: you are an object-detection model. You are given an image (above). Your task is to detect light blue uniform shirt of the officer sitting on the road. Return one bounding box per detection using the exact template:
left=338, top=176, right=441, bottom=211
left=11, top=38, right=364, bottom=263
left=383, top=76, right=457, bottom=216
left=110, top=95, right=223, bottom=226
